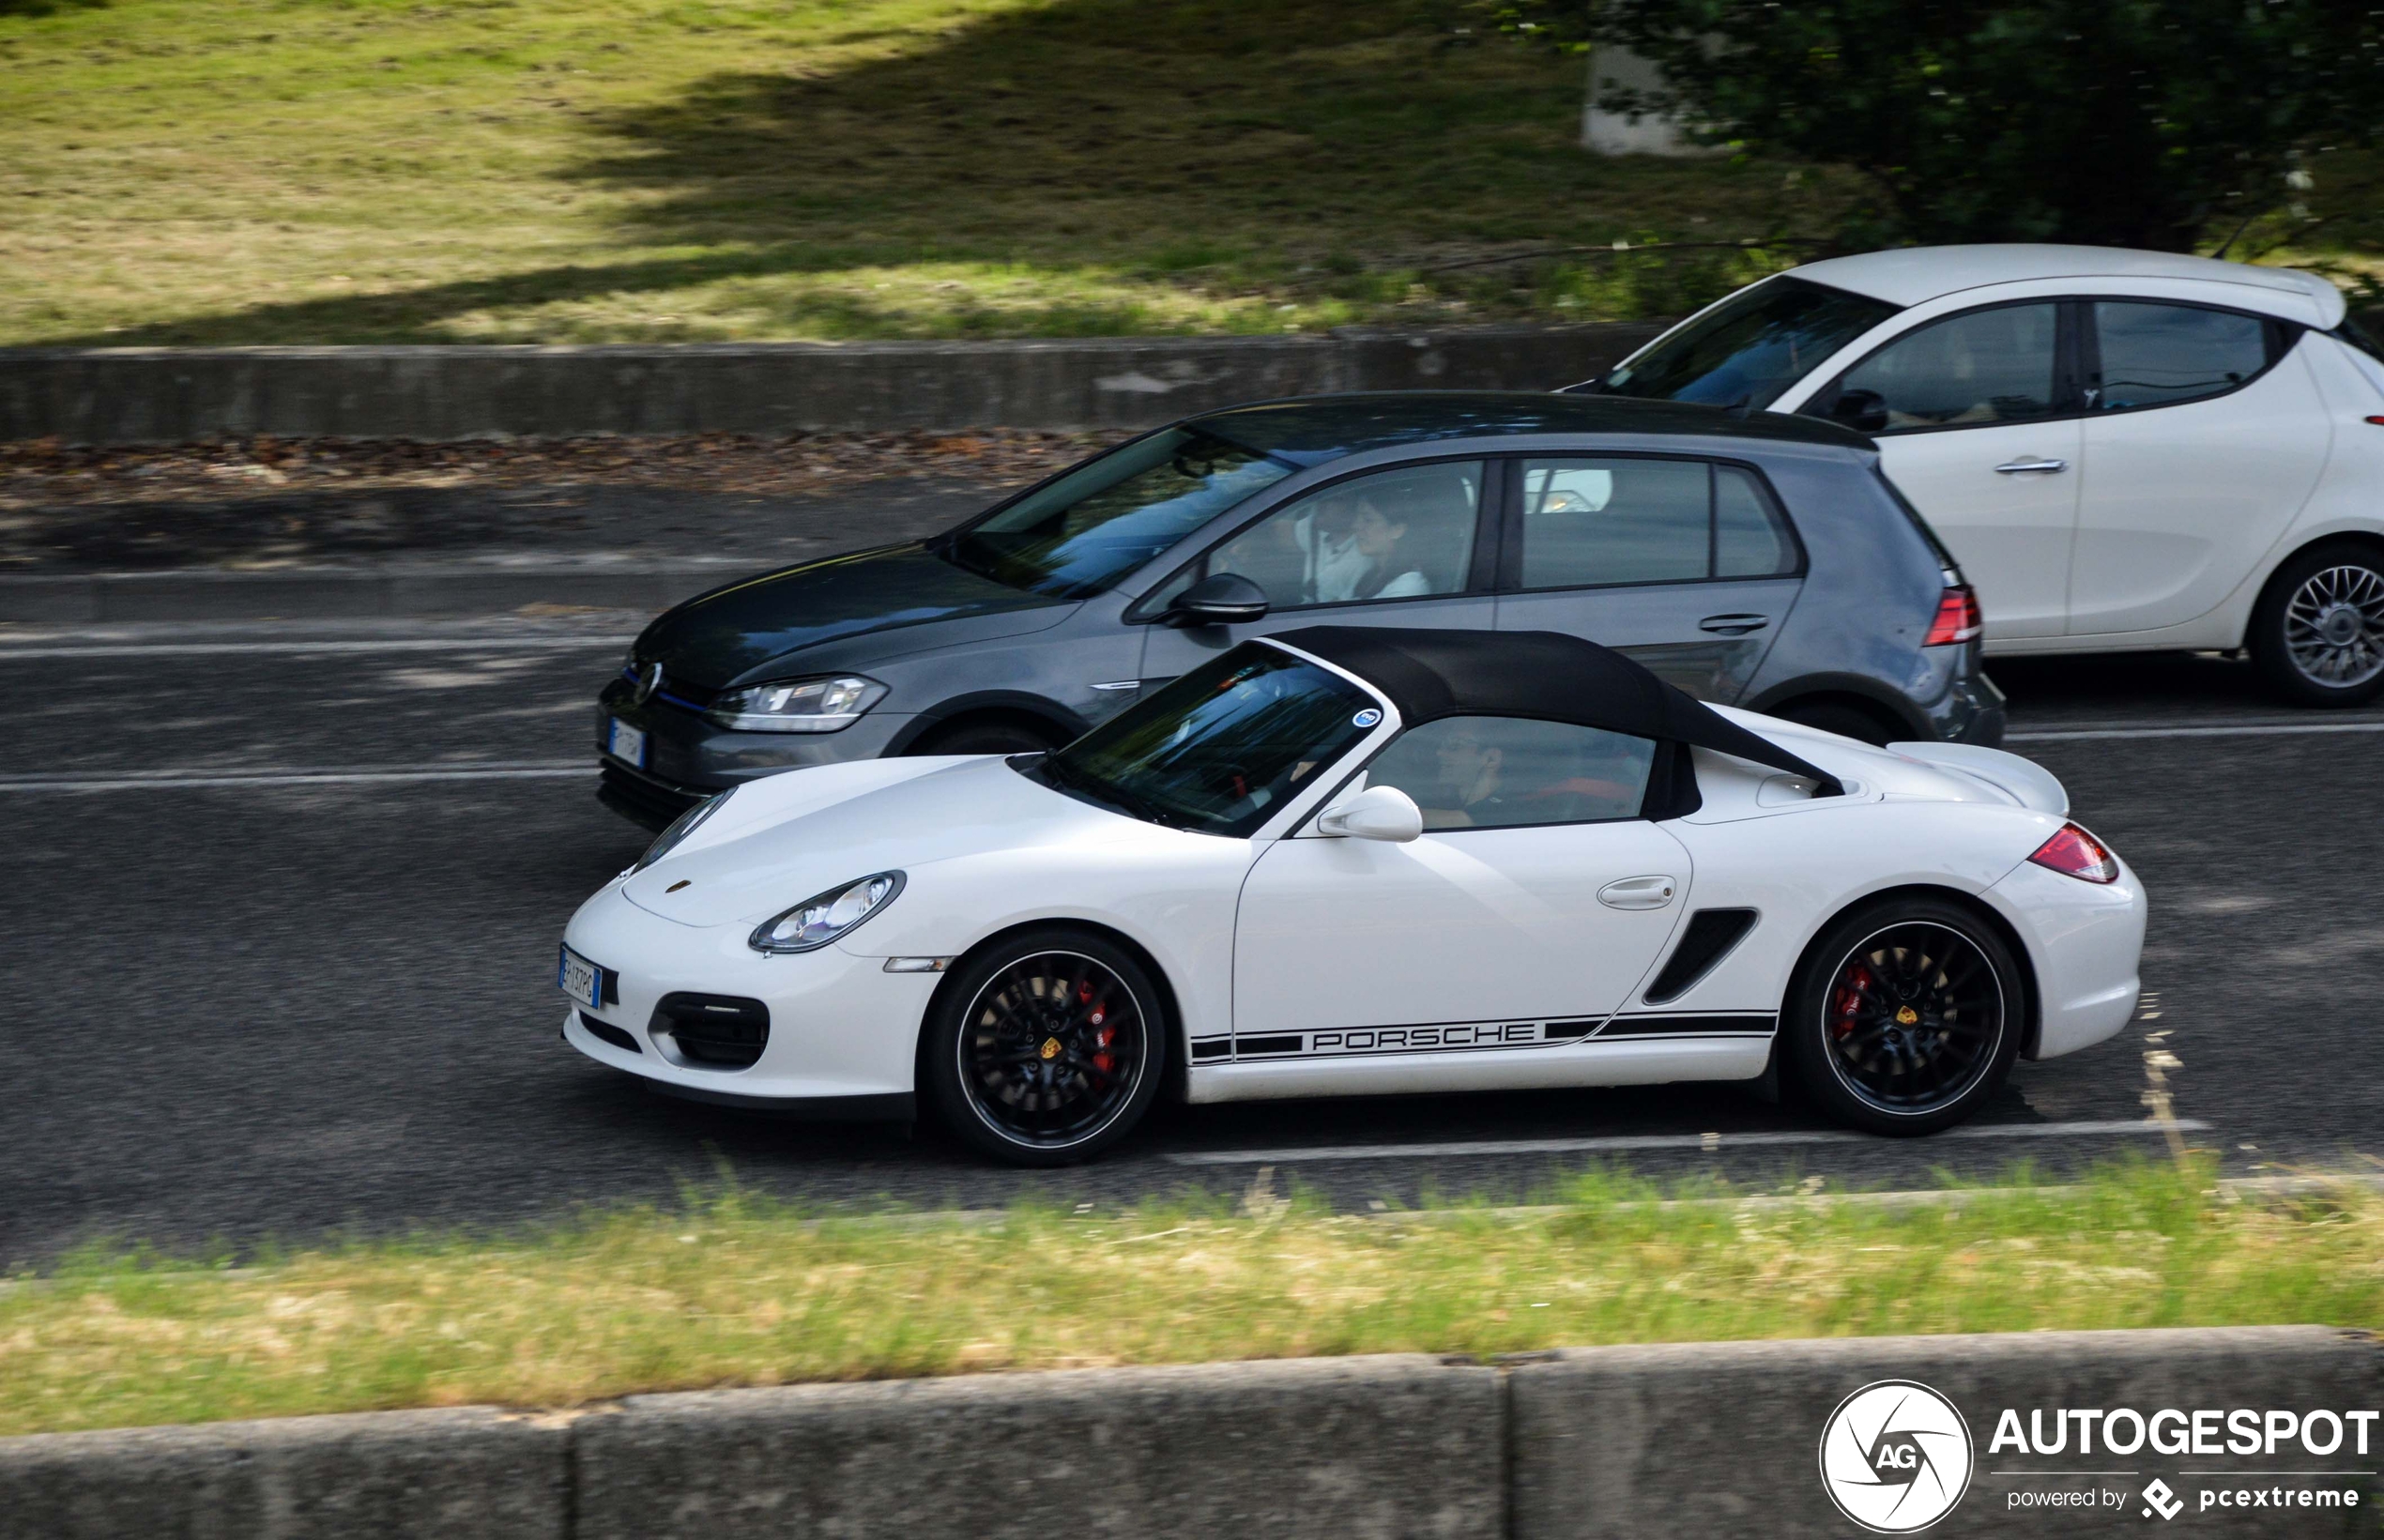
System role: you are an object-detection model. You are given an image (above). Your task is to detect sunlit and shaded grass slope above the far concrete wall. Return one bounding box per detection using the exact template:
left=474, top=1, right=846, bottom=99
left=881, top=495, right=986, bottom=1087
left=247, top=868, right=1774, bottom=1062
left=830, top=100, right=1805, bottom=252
left=0, top=0, right=1833, bottom=345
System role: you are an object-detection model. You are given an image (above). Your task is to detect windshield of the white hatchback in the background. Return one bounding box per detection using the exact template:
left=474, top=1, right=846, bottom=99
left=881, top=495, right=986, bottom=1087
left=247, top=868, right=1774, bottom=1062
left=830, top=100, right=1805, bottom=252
left=1597, top=279, right=1895, bottom=412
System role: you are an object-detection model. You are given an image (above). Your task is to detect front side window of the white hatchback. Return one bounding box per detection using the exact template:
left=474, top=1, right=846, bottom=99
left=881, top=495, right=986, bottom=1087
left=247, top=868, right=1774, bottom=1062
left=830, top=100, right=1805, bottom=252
left=1833, top=303, right=2060, bottom=434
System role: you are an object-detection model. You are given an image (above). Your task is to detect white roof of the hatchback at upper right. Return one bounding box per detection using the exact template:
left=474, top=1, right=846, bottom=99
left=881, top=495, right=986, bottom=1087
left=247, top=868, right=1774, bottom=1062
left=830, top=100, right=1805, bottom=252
left=1796, top=243, right=2344, bottom=329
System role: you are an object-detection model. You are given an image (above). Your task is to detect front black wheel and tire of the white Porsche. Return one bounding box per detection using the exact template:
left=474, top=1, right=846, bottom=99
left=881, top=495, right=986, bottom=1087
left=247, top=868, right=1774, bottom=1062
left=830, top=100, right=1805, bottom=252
left=918, top=925, right=1173, bottom=1166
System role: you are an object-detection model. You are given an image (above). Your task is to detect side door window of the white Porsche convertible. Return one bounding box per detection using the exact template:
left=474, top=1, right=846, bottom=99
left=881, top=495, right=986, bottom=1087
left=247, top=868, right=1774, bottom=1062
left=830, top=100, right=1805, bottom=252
left=1366, top=718, right=1655, bottom=830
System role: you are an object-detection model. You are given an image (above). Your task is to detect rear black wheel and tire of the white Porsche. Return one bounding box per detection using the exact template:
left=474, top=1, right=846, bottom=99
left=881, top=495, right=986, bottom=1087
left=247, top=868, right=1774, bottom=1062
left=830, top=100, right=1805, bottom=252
left=1780, top=896, right=2026, bottom=1135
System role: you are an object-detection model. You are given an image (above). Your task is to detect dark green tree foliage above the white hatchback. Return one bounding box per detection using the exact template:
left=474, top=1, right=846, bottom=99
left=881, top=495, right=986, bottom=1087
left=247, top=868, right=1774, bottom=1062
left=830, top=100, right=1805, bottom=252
left=1495, top=0, right=2384, bottom=251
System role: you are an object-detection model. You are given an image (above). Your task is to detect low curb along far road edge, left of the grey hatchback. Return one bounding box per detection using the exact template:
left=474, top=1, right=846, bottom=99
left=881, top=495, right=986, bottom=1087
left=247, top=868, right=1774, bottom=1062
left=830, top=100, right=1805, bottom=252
left=0, top=557, right=748, bottom=625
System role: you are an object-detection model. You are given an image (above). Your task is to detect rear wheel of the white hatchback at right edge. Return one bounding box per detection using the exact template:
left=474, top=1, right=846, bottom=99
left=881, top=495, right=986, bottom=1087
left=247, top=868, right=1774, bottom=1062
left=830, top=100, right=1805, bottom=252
left=2243, top=541, right=2384, bottom=706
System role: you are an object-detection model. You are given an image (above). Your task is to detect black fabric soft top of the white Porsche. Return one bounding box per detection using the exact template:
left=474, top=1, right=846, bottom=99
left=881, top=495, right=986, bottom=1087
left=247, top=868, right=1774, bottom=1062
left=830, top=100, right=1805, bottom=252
left=1266, top=625, right=1845, bottom=796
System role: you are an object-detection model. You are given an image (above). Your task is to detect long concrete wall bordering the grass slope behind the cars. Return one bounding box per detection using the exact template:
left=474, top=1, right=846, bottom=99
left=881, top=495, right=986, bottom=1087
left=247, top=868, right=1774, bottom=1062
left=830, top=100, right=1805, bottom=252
left=0, top=324, right=1661, bottom=443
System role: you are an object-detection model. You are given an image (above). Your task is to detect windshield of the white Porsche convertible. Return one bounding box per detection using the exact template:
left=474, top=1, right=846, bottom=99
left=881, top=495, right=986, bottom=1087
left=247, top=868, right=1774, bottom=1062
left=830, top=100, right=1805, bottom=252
left=1025, top=644, right=1383, bottom=837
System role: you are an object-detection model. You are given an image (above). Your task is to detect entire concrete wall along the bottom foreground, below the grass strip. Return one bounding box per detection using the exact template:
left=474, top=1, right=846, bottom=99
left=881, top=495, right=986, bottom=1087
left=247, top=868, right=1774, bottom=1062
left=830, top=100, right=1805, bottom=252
left=0, top=1325, right=2384, bottom=1540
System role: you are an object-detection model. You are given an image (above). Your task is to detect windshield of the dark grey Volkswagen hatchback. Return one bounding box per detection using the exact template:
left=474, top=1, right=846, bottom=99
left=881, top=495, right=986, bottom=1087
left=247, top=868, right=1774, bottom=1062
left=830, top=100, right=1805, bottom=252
left=940, top=427, right=1297, bottom=599
